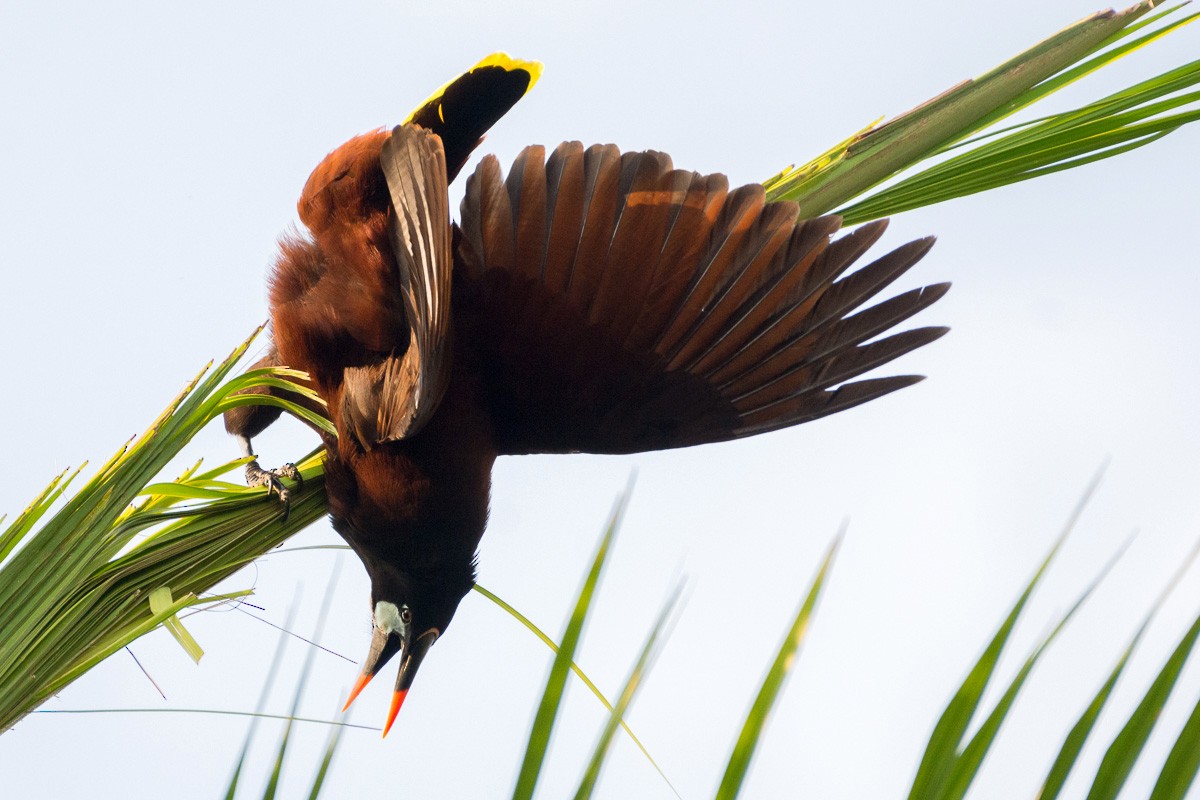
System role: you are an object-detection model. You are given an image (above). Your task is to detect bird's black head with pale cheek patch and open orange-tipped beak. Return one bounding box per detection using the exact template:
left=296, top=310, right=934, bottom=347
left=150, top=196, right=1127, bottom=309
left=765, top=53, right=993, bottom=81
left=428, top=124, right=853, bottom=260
left=343, top=556, right=474, bottom=736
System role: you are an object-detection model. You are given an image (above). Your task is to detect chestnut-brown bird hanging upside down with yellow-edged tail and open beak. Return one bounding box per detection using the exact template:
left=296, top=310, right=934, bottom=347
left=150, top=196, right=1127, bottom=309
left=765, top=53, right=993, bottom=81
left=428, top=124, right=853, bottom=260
left=224, top=53, right=949, bottom=735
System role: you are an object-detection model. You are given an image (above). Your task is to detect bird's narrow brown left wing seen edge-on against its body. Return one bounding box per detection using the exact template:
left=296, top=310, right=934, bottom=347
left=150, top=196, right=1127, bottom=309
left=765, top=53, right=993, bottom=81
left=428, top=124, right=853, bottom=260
left=341, top=125, right=454, bottom=447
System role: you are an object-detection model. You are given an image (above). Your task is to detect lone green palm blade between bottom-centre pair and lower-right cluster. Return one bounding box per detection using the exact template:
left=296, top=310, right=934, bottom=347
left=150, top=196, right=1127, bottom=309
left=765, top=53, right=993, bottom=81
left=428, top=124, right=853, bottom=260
left=715, top=528, right=846, bottom=800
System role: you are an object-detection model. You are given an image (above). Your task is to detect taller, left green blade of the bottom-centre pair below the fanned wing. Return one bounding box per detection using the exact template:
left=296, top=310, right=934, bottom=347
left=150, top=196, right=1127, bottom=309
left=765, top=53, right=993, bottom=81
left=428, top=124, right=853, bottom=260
left=512, top=492, right=629, bottom=800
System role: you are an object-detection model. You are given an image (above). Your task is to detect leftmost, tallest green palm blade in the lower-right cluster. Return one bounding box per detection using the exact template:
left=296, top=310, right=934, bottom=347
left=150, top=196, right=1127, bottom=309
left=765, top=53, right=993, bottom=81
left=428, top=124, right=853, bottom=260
left=908, top=470, right=1103, bottom=800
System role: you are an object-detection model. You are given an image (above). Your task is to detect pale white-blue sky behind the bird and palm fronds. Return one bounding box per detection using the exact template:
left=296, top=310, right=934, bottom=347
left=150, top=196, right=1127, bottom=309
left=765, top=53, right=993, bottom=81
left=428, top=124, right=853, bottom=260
left=0, top=0, right=1200, bottom=799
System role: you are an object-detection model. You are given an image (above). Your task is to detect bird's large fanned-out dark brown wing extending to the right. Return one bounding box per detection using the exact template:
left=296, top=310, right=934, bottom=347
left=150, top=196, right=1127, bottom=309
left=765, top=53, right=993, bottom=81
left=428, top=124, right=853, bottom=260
left=456, top=143, right=948, bottom=453
